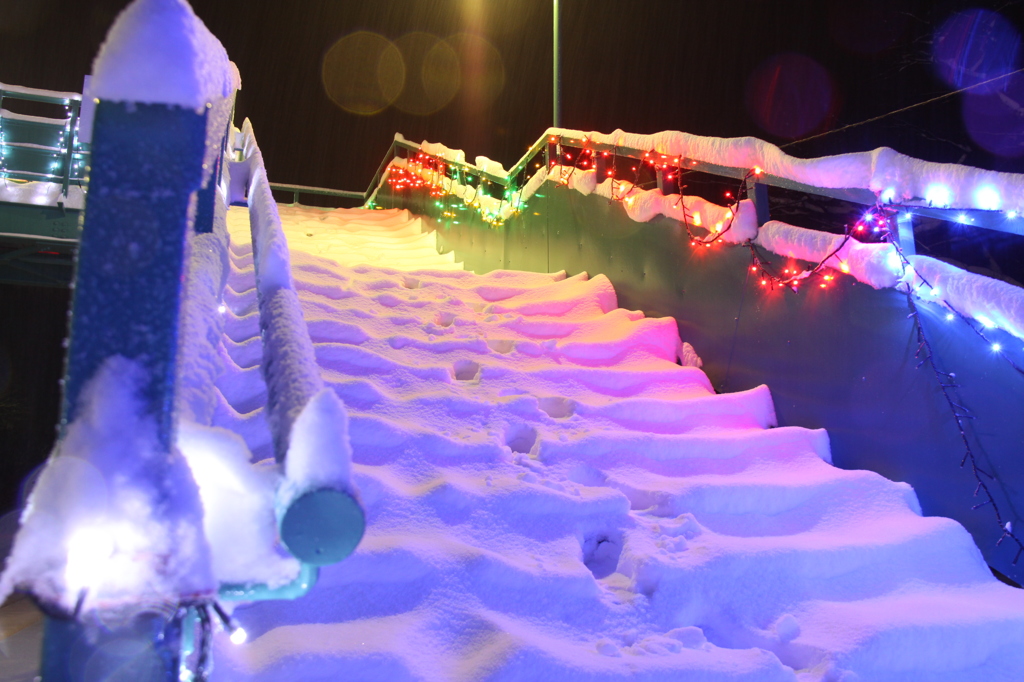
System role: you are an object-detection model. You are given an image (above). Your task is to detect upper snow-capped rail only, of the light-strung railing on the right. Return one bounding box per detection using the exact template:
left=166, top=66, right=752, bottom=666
left=368, top=128, right=1024, bottom=244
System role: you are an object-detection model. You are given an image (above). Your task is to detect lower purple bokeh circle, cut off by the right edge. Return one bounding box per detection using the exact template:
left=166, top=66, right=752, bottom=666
left=963, top=74, right=1024, bottom=158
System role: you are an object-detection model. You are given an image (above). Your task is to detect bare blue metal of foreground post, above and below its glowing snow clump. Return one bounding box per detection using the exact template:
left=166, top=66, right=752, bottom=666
left=47, top=101, right=215, bottom=682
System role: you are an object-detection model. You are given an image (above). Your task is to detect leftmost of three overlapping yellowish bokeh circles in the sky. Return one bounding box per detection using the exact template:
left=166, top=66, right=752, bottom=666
left=321, top=31, right=406, bottom=116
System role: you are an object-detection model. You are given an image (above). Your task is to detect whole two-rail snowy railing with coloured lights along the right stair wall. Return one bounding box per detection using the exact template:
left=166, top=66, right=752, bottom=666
left=380, top=128, right=1024, bottom=339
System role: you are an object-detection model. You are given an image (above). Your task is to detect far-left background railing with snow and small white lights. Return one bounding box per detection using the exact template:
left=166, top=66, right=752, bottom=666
left=0, top=83, right=89, bottom=197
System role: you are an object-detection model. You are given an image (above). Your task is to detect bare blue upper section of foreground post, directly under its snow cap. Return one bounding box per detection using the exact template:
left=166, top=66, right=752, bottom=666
left=60, top=101, right=207, bottom=440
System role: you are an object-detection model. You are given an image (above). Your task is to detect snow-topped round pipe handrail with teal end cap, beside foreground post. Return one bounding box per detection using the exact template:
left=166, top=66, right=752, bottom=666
left=233, top=120, right=366, bottom=564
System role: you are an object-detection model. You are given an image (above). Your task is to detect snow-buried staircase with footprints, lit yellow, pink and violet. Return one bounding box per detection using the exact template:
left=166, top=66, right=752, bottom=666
left=215, top=206, right=1024, bottom=682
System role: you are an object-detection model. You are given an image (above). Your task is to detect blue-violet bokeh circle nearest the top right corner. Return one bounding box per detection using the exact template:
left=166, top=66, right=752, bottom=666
left=932, top=9, right=1021, bottom=94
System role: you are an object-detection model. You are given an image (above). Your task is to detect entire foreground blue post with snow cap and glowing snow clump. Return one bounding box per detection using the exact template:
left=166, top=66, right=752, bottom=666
left=0, top=0, right=239, bottom=682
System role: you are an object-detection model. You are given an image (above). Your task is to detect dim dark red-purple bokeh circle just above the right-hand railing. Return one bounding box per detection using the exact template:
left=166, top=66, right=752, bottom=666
left=745, top=52, right=838, bottom=139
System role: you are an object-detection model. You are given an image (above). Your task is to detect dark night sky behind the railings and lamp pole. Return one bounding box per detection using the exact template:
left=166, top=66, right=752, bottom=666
left=0, top=0, right=1024, bottom=189
